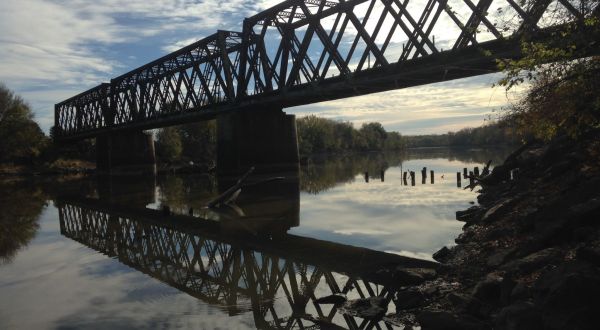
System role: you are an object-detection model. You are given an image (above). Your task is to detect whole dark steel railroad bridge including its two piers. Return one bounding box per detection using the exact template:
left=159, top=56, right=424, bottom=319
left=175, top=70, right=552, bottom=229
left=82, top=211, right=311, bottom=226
left=54, top=0, right=598, bottom=171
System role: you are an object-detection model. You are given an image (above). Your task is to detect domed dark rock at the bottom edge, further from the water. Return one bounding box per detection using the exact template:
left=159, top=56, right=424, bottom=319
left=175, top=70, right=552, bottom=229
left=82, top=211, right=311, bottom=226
left=495, top=301, right=543, bottom=330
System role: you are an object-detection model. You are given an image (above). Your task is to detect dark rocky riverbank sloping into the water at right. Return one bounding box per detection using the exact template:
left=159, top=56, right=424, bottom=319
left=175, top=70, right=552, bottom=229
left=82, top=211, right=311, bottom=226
left=386, top=131, right=600, bottom=330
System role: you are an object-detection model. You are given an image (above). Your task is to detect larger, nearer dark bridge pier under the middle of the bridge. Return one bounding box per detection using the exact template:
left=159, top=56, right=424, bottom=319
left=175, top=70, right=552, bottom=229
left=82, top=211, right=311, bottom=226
left=217, top=108, right=299, bottom=174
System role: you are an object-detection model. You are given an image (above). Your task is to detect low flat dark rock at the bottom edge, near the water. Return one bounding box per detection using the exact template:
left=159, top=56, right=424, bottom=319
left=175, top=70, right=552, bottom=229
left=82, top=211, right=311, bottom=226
left=417, top=311, right=489, bottom=330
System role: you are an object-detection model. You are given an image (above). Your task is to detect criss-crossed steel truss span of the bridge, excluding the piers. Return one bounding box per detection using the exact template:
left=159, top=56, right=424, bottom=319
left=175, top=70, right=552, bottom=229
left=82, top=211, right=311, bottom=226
left=56, top=0, right=597, bottom=137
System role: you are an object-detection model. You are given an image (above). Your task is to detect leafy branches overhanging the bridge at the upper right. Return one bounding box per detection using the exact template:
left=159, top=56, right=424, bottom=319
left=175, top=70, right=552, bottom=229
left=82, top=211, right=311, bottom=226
left=498, top=0, right=600, bottom=140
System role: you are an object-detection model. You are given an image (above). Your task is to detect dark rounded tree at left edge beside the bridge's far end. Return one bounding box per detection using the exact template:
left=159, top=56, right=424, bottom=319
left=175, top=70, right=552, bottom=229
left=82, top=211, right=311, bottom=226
left=0, top=84, right=49, bottom=163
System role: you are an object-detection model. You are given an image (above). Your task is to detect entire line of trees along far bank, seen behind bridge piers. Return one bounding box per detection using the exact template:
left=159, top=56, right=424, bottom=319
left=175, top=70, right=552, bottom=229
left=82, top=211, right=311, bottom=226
left=0, top=83, right=519, bottom=176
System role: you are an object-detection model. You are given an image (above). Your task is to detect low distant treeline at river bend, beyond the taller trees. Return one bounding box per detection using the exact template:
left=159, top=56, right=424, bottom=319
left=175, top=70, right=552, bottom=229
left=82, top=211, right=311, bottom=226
left=403, top=122, right=522, bottom=148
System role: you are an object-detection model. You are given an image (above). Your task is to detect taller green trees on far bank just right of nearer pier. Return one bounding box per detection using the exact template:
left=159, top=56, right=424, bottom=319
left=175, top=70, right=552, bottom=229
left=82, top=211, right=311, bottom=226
left=296, top=115, right=404, bottom=155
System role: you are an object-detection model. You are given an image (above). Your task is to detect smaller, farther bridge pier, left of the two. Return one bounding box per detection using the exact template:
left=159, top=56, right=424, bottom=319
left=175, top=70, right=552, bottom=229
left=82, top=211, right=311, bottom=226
left=96, top=131, right=156, bottom=175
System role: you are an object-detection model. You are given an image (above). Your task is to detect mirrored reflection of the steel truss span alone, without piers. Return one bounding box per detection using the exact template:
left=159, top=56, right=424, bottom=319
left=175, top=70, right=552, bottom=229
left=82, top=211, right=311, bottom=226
left=57, top=199, right=435, bottom=329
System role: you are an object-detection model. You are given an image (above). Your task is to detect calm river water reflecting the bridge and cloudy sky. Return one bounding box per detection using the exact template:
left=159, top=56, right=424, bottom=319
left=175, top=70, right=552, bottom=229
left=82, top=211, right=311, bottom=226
left=0, top=149, right=507, bottom=329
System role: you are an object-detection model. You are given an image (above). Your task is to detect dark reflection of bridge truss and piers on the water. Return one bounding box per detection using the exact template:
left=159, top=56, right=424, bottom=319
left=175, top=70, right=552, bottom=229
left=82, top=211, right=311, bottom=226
left=55, top=169, right=435, bottom=329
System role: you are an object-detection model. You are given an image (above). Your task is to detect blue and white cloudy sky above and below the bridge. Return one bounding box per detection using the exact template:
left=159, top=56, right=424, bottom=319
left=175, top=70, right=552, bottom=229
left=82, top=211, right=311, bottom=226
left=0, top=0, right=515, bottom=135
